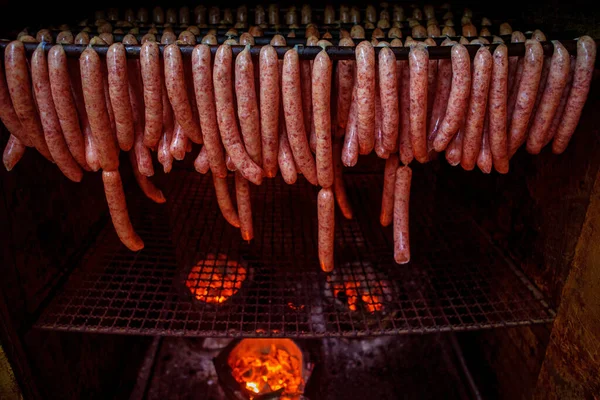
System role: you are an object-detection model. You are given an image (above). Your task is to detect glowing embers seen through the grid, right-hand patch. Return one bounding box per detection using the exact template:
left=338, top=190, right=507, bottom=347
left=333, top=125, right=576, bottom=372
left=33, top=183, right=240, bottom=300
left=327, top=266, right=392, bottom=313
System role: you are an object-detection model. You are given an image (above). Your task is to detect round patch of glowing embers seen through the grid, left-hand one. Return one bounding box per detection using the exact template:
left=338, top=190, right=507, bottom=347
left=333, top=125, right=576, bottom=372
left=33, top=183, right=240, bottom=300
left=185, top=254, right=247, bottom=304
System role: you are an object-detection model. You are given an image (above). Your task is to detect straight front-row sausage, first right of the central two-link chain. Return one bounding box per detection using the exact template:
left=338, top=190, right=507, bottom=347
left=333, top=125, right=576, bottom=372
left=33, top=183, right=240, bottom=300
left=356, top=41, right=375, bottom=154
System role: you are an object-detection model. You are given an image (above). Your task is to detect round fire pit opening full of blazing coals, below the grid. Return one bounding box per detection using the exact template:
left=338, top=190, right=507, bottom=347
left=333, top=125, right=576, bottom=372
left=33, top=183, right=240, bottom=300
left=227, top=339, right=309, bottom=398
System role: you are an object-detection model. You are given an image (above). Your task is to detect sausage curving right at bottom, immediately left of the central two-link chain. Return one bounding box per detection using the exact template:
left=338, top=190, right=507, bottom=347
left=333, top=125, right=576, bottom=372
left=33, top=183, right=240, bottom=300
left=281, top=49, right=317, bottom=185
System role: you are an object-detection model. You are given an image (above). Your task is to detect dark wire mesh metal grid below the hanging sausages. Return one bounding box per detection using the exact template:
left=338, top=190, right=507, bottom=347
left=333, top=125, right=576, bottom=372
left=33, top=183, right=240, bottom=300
left=36, top=171, right=555, bottom=337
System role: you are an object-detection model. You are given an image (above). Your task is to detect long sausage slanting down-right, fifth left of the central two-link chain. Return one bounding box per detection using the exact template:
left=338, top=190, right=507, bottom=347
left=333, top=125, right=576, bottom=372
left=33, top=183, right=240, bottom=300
left=192, top=44, right=227, bottom=178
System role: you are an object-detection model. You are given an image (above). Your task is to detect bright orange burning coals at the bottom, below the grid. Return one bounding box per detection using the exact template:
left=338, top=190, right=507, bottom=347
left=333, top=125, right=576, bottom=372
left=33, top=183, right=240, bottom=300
left=228, top=339, right=304, bottom=395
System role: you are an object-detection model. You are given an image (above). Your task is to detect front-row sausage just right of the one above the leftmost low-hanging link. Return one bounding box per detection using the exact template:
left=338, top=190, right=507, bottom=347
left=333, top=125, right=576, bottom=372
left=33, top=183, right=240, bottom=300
left=108, top=43, right=137, bottom=151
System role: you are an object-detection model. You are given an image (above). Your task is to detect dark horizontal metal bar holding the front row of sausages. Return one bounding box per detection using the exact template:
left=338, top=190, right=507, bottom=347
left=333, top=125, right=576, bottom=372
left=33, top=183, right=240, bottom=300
left=0, top=40, right=600, bottom=60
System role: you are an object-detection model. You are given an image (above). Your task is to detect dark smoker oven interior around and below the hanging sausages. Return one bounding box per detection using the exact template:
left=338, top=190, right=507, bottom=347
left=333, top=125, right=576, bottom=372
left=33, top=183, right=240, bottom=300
left=0, top=1, right=600, bottom=399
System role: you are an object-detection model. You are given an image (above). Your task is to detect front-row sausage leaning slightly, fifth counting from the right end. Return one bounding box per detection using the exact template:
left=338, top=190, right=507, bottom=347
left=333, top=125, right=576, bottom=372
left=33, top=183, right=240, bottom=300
left=461, top=47, right=492, bottom=171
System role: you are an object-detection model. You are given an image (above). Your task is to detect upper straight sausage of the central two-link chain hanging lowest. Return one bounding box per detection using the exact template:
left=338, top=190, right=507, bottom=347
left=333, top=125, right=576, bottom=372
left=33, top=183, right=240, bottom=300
left=312, top=50, right=336, bottom=188
